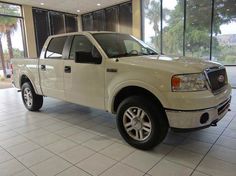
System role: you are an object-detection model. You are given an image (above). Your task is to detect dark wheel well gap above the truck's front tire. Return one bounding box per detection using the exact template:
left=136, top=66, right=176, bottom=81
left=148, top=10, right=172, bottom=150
left=113, top=86, right=163, bottom=113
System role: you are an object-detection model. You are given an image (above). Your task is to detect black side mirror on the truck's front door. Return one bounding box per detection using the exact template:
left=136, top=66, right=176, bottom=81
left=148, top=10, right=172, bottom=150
left=75, top=46, right=102, bottom=64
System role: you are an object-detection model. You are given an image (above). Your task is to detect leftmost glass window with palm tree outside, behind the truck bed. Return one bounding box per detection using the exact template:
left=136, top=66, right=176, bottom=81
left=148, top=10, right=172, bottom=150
left=0, top=3, right=26, bottom=77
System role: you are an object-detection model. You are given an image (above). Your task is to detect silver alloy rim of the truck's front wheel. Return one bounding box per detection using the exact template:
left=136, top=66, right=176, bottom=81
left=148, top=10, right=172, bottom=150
left=123, top=107, right=152, bottom=141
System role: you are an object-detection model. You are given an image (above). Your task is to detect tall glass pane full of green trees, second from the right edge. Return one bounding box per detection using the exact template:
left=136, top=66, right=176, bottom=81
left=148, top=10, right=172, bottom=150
left=185, top=0, right=212, bottom=60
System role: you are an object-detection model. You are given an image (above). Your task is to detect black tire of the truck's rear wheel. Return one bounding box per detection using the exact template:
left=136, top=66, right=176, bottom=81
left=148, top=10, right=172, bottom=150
left=21, top=82, right=43, bottom=111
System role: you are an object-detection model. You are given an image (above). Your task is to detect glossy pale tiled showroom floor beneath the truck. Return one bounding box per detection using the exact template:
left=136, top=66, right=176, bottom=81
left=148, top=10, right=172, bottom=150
left=0, top=89, right=236, bottom=176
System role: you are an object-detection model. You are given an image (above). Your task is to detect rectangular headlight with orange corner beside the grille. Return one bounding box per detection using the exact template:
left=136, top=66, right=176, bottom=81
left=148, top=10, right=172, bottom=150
left=171, top=73, right=207, bottom=92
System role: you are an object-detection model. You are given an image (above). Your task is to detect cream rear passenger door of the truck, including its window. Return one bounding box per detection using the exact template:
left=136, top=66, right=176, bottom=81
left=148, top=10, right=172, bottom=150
left=39, top=36, right=67, bottom=99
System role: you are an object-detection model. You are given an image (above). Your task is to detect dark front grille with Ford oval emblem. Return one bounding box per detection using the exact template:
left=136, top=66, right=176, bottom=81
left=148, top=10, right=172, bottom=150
left=206, top=67, right=228, bottom=93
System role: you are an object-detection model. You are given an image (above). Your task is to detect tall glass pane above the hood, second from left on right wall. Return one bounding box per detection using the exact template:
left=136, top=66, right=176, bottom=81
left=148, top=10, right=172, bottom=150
left=162, top=0, right=184, bottom=55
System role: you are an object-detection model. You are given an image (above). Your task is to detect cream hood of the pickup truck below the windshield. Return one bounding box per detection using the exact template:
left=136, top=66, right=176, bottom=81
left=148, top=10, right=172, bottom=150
left=119, top=55, right=222, bottom=74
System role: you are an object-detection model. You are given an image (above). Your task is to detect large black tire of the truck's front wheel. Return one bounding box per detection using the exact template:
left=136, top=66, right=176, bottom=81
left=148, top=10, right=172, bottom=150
left=117, top=96, right=169, bottom=150
